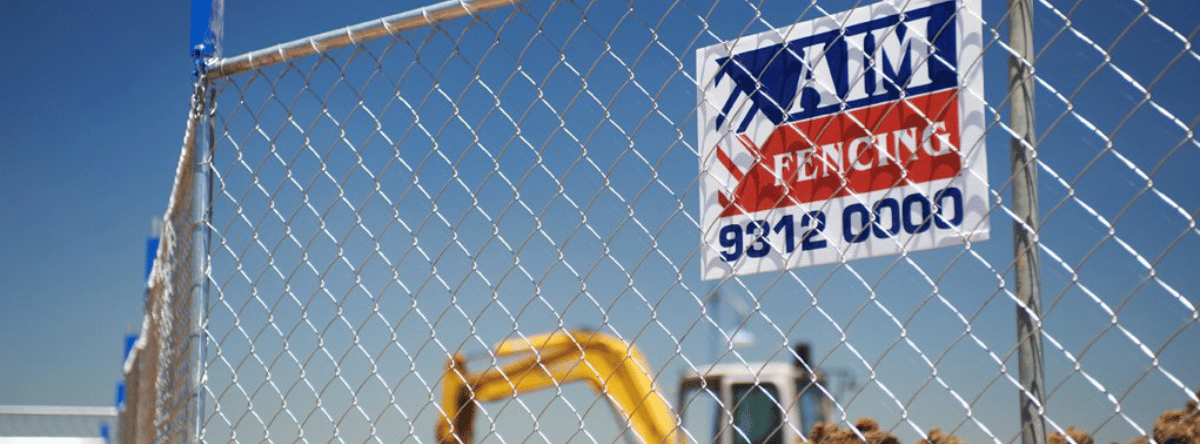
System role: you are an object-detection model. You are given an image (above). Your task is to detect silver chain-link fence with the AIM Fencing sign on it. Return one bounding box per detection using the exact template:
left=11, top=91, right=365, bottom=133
left=129, top=0, right=1200, bottom=444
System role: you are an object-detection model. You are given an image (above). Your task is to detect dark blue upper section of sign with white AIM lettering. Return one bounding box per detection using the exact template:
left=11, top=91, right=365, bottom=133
left=714, top=1, right=958, bottom=133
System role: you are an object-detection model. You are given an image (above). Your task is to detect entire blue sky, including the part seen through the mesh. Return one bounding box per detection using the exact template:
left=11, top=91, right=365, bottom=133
left=0, top=0, right=1200, bottom=443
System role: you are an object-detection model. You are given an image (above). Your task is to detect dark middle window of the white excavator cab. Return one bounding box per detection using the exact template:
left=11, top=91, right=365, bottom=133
left=732, top=384, right=784, bottom=444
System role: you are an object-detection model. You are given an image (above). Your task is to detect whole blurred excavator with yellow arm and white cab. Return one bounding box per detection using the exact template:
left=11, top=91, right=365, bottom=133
left=434, top=331, right=833, bottom=444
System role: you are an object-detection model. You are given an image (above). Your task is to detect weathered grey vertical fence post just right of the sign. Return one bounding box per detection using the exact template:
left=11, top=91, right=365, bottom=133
left=1008, top=0, right=1046, bottom=444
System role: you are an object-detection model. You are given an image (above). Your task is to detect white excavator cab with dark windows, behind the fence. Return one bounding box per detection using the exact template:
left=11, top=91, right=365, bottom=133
left=676, top=347, right=832, bottom=444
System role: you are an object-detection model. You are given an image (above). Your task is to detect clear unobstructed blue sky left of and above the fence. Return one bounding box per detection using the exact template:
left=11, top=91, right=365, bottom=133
left=0, top=0, right=432, bottom=406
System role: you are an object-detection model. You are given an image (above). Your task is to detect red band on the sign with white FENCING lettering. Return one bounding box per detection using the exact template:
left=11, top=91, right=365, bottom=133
left=718, top=89, right=962, bottom=217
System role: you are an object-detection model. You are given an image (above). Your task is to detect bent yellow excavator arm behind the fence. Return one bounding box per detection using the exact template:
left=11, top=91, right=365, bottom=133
left=436, top=331, right=686, bottom=444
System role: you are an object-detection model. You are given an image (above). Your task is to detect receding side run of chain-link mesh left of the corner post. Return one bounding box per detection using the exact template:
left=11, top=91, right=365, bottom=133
left=115, top=83, right=205, bottom=443
